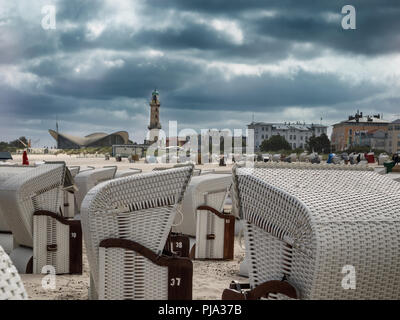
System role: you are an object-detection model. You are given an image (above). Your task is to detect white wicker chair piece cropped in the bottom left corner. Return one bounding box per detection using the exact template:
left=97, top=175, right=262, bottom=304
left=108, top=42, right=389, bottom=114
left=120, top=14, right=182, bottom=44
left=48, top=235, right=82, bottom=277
left=0, top=246, right=28, bottom=301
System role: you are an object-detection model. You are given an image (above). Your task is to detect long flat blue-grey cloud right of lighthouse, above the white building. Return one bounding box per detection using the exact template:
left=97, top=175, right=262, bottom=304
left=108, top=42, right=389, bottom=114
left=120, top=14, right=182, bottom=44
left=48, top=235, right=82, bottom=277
left=164, top=71, right=384, bottom=112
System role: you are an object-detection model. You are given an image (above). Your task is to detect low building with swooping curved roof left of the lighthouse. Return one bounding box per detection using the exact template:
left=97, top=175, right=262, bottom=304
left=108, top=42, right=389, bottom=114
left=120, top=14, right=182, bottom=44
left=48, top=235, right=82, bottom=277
left=49, top=130, right=130, bottom=149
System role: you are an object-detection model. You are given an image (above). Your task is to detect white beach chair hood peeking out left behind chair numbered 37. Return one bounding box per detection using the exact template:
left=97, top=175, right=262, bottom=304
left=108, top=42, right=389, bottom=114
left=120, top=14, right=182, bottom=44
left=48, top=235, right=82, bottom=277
left=75, top=166, right=117, bottom=212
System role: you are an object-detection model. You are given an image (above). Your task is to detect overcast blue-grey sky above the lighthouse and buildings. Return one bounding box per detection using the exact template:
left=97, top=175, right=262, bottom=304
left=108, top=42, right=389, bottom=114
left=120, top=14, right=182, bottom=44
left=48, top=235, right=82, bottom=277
left=0, top=0, right=400, bottom=146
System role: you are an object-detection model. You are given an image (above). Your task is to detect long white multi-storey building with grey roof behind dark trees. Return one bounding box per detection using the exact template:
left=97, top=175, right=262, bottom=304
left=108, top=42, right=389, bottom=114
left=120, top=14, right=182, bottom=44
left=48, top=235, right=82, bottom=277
left=247, top=122, right=328, bottom=151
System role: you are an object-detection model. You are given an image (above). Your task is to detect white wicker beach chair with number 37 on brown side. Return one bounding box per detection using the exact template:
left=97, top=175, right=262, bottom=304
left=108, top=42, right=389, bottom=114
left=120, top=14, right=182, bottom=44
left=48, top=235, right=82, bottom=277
left=81, top=166, right=193, bottom=300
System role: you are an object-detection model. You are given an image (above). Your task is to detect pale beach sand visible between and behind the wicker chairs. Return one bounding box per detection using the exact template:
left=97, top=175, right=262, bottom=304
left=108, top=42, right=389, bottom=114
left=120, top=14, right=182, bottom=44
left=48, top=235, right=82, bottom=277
left=13, top=155, right=247, bottom=300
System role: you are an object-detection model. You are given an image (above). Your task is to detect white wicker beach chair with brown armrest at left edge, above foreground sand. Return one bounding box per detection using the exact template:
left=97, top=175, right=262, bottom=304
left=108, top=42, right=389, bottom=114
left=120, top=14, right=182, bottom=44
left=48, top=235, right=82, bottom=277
left=0, top=163, right=82, bottom=274
